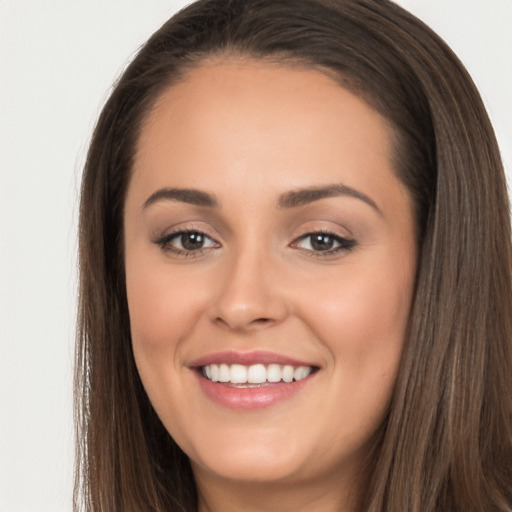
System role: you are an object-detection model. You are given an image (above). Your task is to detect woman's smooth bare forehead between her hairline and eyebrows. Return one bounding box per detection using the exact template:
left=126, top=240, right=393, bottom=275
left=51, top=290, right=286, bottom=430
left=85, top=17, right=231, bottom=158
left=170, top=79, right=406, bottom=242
left=133, top=60, right=406, bottom=211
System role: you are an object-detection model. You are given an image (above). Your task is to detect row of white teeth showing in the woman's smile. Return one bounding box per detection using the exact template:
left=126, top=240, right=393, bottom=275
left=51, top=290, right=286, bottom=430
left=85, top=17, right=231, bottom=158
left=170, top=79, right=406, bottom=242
left=199, top=363, right=318, bottom=388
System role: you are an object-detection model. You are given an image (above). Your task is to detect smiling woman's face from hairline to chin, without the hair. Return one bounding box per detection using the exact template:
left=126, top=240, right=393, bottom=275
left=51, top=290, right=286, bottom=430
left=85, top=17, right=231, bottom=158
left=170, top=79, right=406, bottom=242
left=125, top=60, right=417, bottom=492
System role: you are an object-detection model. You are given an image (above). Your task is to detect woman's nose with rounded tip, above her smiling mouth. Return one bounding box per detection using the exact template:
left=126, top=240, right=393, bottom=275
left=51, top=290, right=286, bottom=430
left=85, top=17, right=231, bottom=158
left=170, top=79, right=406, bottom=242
left=209, top=245, right=289, bottom=331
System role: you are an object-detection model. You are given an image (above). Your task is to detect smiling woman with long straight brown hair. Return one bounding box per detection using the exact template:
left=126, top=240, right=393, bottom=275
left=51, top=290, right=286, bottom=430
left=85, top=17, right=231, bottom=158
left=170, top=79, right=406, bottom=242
left=77, top=0, right=512, bottom=512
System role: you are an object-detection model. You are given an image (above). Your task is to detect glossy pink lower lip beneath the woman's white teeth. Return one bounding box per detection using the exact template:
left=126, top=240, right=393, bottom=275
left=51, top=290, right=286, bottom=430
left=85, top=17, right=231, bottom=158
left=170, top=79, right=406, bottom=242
left=196, top=372, right=314, bottom=410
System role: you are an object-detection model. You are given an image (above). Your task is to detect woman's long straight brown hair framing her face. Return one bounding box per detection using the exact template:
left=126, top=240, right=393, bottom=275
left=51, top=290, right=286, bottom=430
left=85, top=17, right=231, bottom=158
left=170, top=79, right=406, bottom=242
left=75, top=0, right=512, bottom=512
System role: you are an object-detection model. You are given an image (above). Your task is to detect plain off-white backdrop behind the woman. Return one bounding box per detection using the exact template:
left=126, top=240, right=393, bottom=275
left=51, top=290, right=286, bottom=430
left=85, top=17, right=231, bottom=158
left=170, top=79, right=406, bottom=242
left=0, top=0, right=512, bottom=512
